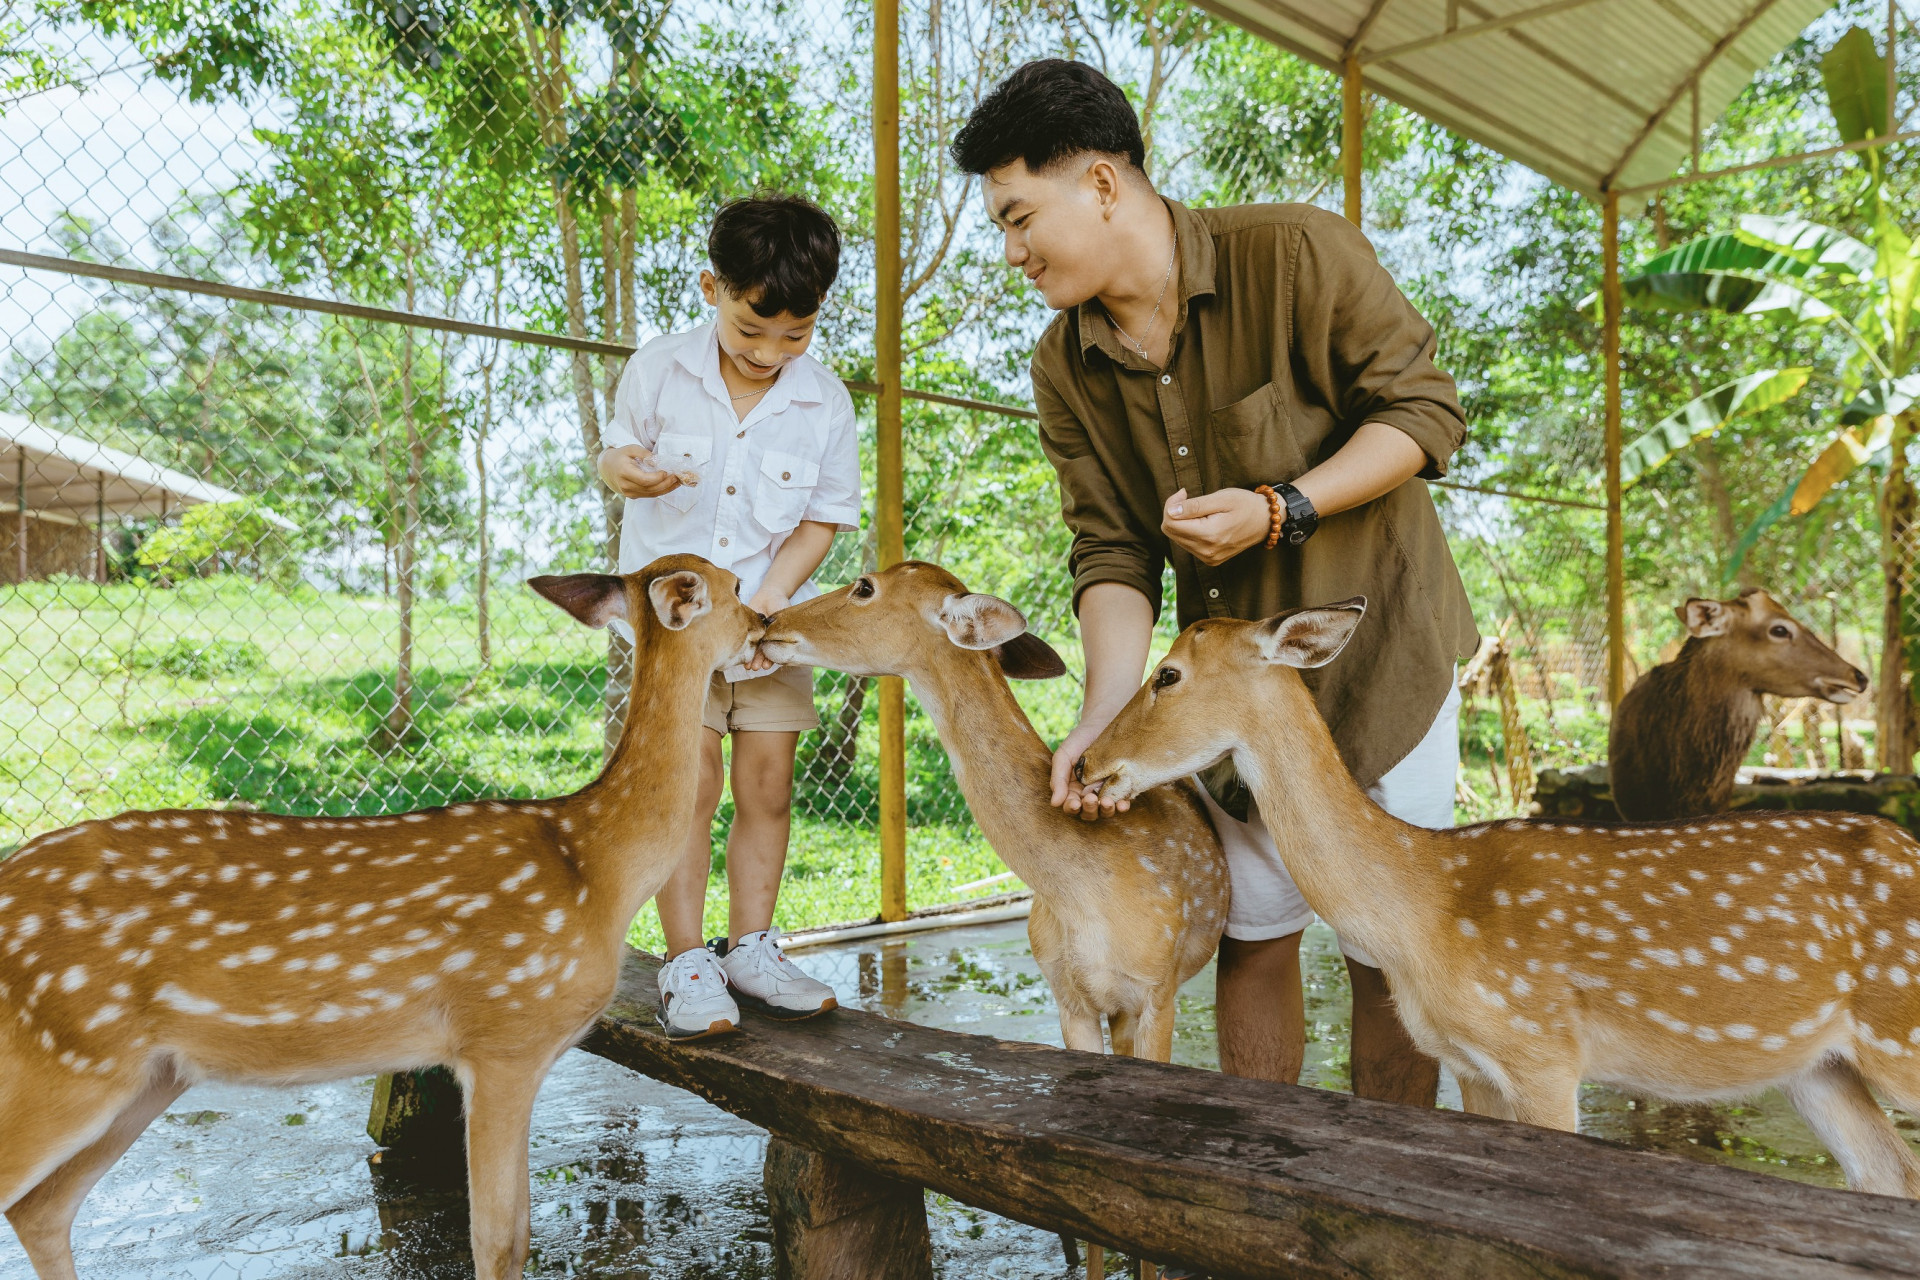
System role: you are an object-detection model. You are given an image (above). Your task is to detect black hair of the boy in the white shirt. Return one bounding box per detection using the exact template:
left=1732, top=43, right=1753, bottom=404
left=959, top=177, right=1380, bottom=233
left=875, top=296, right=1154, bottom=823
left=707, top=194, right=839, bottom=317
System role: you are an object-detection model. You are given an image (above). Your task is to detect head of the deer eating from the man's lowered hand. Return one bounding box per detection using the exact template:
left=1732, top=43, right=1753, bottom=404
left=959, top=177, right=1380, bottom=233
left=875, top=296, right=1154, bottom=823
left=1079, top=595, right=1367, bottom=800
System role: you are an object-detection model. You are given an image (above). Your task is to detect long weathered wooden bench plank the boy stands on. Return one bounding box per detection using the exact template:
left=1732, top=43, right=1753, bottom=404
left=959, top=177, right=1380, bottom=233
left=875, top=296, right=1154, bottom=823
left=584, top=954, right=1920, bottom=1280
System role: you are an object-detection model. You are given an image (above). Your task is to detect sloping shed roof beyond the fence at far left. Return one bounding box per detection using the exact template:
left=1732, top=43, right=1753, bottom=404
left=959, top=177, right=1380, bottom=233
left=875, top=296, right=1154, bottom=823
left=0, top=415, right=298, bottom=530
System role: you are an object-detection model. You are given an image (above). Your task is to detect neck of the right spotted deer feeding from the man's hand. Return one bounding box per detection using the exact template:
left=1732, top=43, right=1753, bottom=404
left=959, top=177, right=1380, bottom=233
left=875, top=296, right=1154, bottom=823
left=1233, top=670, right=1446, bottom=965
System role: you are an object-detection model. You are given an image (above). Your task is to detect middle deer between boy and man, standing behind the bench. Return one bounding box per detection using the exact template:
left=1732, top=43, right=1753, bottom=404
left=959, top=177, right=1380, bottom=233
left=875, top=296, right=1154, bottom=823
left=760, top=560, right=1227, bottom=1061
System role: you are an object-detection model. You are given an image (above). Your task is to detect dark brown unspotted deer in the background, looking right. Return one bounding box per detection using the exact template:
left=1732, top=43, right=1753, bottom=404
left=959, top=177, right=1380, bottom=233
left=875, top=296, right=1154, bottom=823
left=1607, top=587, right=1866, bottom=821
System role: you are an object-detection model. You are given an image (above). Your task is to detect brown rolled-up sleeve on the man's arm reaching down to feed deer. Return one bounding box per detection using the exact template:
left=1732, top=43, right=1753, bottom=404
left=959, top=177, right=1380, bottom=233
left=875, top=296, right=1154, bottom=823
left=1033, top=365, right=1164, bottom=618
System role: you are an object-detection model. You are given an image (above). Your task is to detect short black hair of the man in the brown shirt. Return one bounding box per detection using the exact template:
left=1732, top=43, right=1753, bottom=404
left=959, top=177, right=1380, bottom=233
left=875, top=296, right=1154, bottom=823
left=952, top=58, right=1146, bottom=173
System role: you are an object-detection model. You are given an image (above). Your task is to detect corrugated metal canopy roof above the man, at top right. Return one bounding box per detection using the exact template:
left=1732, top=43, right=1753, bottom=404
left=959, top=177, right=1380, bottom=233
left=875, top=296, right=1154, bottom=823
left=1200, top=0, right=1832, bottom=196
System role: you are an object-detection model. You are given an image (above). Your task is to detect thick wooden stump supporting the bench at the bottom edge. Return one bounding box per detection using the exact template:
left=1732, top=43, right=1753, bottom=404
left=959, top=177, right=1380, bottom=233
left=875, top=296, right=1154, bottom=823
left=764, top=1138, right=933, bottom=1280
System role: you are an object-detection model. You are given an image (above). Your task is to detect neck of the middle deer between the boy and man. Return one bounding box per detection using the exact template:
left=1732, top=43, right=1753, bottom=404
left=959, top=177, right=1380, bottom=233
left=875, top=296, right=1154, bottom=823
left=906, top=647, right=1079, bottom=894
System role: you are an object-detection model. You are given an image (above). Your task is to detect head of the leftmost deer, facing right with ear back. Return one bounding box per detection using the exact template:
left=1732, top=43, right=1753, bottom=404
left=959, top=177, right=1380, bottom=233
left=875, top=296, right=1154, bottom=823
left=526, top=555, right=766, bottom=670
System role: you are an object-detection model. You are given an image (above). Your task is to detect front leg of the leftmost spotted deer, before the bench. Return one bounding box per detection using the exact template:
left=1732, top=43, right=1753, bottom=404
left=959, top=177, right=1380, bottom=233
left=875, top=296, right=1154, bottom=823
left=459, top=1061, right=551, bottom=1280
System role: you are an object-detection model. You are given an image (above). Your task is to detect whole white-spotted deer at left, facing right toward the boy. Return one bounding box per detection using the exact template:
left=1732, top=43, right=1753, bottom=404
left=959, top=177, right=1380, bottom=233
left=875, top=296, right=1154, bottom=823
left=0, top=557, right=764, bottom=1280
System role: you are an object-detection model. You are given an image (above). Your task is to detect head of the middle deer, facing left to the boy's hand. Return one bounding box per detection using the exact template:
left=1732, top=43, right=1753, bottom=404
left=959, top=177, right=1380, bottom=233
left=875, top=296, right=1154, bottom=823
left=760, top=560, right=1068, bottom=679
